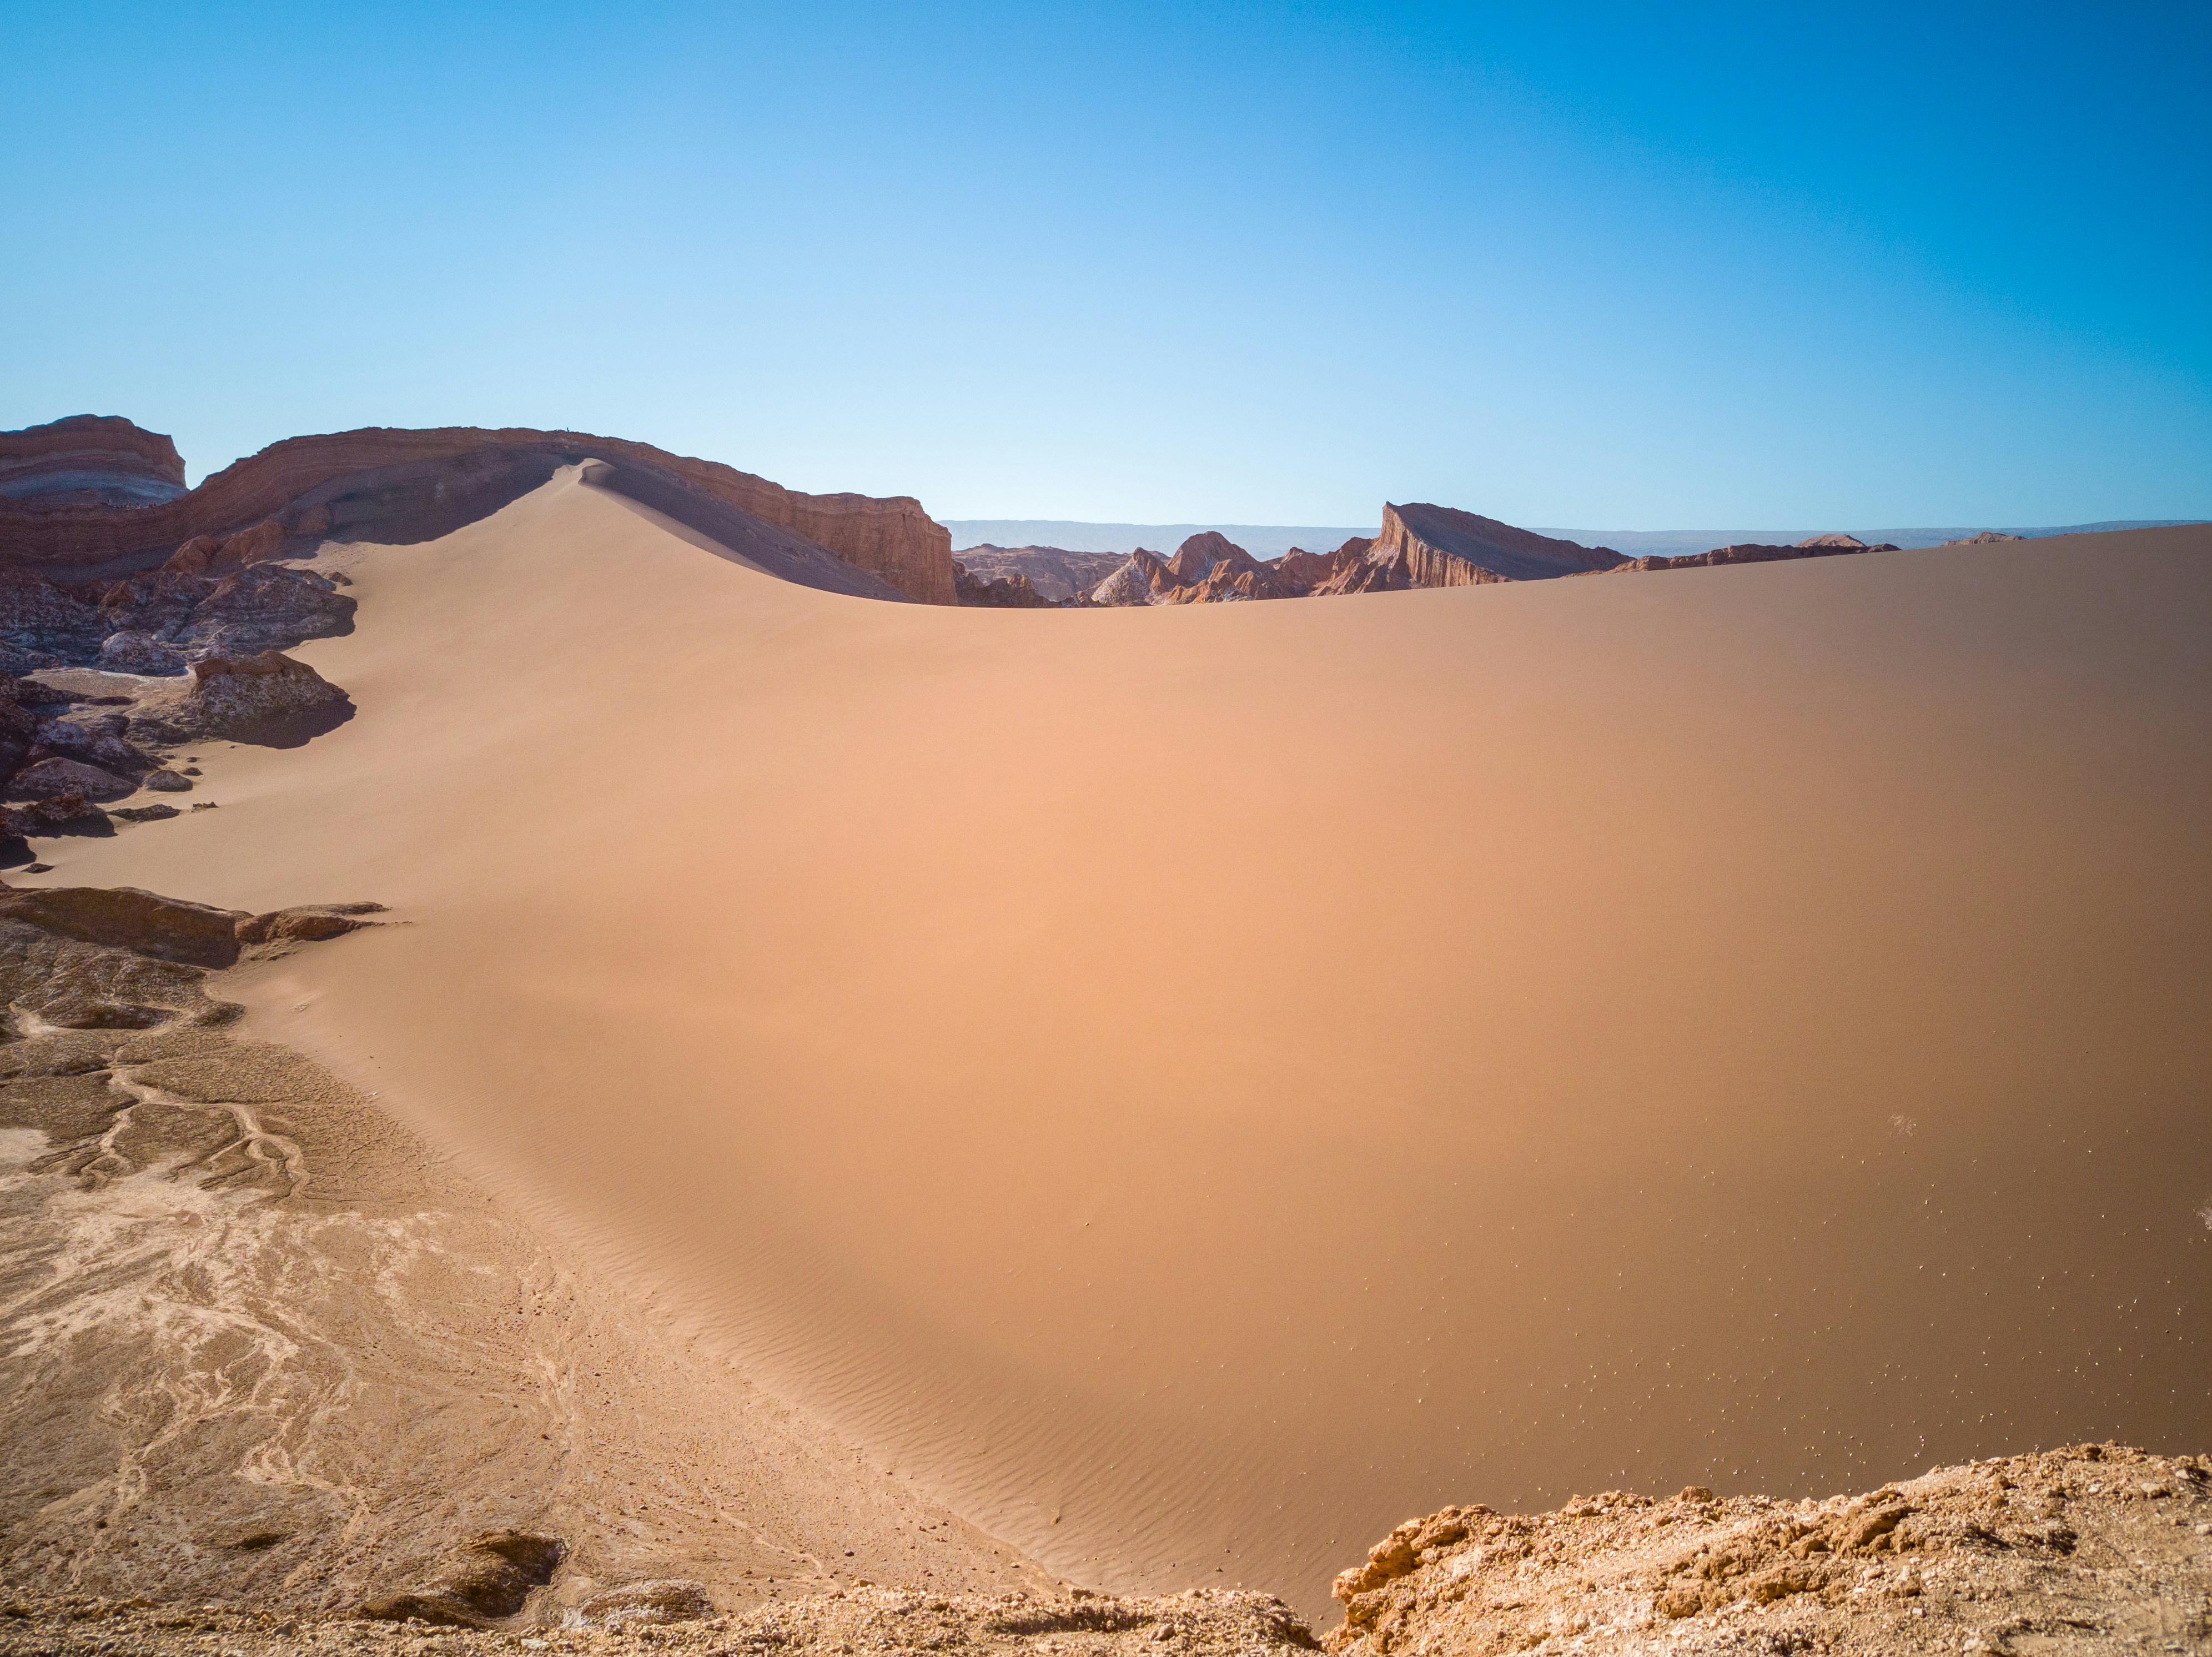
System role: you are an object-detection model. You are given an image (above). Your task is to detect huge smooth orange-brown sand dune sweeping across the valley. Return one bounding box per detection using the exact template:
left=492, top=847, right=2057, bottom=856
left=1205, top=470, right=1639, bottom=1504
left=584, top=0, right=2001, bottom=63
left=26, top=474, right=2212, bottom=1613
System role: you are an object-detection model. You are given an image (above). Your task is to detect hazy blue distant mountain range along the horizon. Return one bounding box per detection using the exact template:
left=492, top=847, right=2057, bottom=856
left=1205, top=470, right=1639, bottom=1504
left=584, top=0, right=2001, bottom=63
left=940, top=518, right=2205, bottom=558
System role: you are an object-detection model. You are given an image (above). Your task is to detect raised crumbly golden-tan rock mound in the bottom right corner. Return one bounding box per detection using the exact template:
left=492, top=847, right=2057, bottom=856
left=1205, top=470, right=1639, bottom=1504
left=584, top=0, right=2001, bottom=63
left=1325, top=1445, right=2212, bottom=1657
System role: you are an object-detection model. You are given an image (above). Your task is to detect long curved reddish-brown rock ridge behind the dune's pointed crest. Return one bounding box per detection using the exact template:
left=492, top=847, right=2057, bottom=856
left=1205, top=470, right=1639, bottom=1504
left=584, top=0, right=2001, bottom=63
left=0, top=427, right=956, bottom=604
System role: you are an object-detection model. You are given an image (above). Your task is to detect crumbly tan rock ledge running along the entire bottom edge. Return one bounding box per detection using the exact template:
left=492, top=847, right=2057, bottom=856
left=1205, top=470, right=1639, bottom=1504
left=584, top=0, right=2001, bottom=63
left=0, top=1445, right=2212, bottom=1657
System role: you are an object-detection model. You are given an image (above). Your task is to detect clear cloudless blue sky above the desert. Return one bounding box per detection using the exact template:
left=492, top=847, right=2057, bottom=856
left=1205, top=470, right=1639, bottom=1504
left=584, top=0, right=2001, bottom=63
left=0, top=0, right=2212, bottom=529
